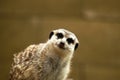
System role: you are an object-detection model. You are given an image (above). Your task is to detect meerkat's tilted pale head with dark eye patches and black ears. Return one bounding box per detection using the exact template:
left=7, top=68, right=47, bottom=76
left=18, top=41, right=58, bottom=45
left=49, top=29, right=79, bottom=52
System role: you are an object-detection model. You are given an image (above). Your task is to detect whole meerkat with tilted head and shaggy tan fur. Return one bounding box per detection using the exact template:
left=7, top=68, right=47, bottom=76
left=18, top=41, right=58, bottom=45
left=9, top=29, right=79, bottom=80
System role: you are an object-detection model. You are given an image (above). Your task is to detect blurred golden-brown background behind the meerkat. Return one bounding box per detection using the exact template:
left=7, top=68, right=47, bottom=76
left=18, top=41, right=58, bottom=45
left=0, top=0, right=120, bottom=80
